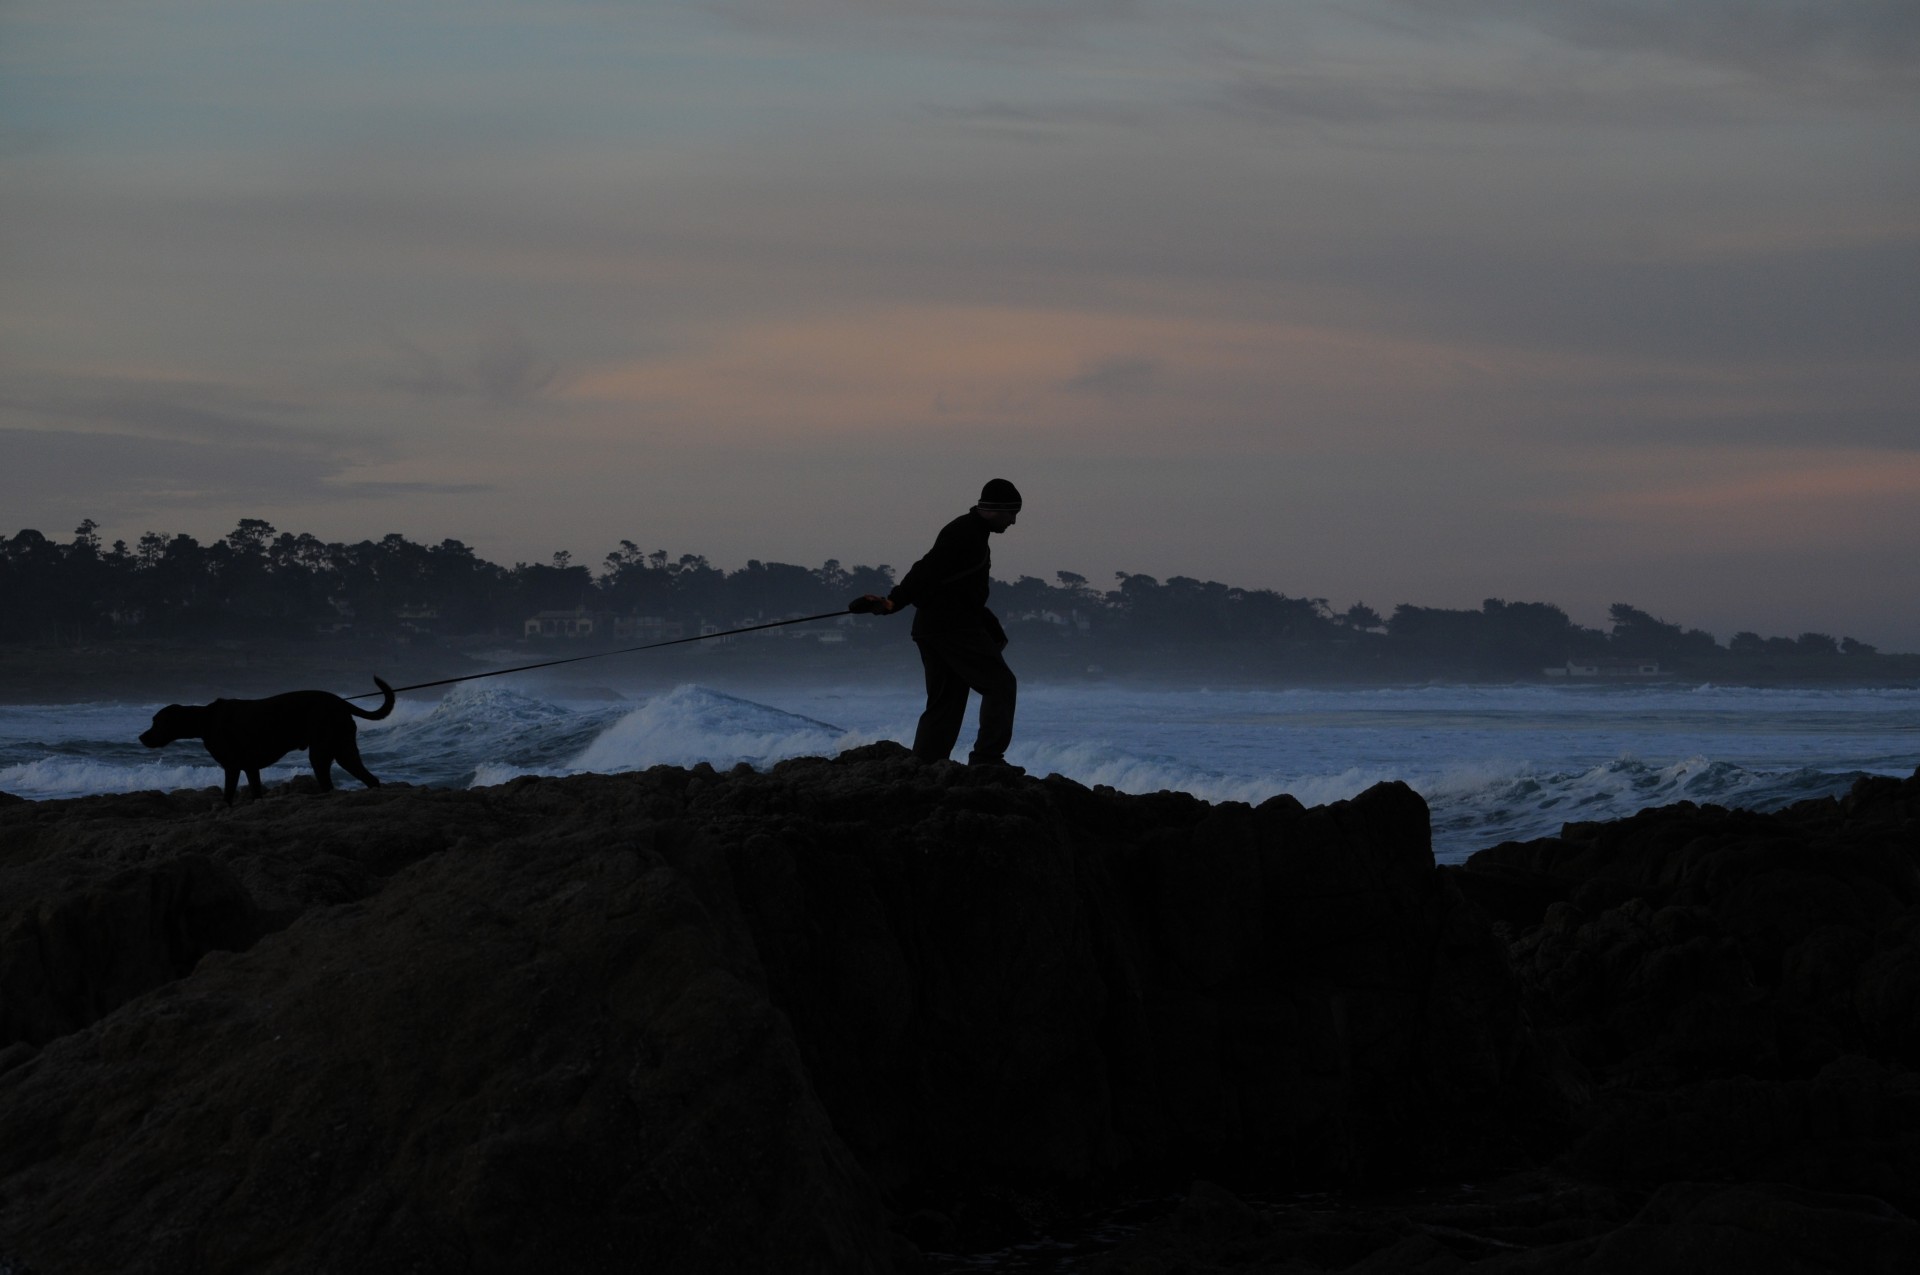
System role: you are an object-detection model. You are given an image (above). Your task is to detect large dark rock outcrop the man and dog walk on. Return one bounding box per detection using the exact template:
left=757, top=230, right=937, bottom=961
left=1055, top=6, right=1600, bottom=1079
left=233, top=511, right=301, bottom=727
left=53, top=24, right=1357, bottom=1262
left=0, top=745, right=1530, bottom=1275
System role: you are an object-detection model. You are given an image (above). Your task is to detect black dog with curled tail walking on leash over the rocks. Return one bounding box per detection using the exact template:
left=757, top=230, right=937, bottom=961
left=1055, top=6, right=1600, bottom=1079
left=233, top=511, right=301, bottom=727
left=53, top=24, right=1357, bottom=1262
left=140, top=678, right=394, bottom=806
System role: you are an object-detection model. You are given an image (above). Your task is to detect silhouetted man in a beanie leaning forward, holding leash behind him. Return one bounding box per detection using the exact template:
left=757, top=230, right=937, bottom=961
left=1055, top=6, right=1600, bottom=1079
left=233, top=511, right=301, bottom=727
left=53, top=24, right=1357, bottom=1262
left=852, top=478, right=1020, bottom=766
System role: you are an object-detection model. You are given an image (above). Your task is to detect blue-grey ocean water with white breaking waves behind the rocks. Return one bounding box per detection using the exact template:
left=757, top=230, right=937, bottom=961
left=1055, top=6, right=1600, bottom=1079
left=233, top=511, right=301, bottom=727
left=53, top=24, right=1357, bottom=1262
left=0, top=678, right=1920, bottom=862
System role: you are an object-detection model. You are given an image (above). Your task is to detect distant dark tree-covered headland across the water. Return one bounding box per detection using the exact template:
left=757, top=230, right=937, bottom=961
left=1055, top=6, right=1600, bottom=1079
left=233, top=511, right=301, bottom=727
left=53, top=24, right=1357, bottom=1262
left=0, top=518, right=1876, bottom=672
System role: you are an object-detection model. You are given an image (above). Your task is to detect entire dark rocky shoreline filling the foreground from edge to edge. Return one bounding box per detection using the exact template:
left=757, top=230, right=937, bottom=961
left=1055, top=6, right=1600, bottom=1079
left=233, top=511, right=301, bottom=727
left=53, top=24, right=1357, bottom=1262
left=0, top=745, right=1920, bottom=1275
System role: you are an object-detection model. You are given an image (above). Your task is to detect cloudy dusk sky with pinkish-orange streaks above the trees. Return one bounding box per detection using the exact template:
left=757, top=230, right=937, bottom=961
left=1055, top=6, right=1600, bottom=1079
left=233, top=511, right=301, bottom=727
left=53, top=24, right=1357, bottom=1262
left=0, top=0, right=1920, bottom=651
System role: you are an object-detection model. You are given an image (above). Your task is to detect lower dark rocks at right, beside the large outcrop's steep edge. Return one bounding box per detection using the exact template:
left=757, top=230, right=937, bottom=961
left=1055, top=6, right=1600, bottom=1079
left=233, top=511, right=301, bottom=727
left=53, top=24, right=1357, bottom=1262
left=1096, top=760, right=1920, bottom=1275
